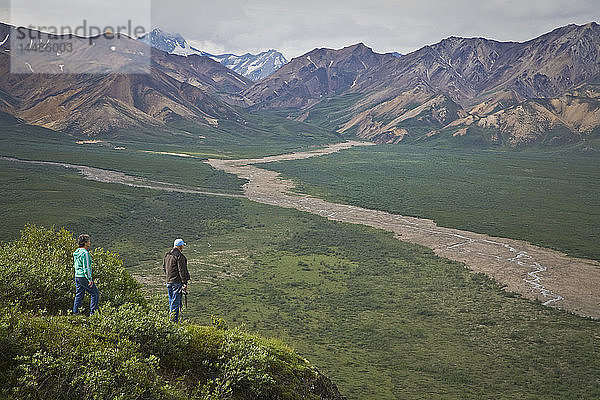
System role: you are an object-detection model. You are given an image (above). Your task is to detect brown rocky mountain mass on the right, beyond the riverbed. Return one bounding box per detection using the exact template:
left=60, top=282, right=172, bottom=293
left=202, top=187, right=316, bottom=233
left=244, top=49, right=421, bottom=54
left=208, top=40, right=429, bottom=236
left=244, top=22, right=600, bottom=145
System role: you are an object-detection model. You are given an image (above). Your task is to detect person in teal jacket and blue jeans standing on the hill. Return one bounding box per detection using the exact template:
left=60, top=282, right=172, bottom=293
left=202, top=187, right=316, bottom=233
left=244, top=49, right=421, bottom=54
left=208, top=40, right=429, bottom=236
left=73, top=234, right=100, bottom=315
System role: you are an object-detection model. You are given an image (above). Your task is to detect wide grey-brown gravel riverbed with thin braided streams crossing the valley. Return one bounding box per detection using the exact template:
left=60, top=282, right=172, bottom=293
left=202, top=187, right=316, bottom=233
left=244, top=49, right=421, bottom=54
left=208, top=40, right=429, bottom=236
left=206, top=142, right=600, bottom=318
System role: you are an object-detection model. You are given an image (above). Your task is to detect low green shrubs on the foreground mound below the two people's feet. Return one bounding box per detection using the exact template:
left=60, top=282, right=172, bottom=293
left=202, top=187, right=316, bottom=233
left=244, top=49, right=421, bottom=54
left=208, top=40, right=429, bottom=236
left=0, top=304, right=323, bottom=400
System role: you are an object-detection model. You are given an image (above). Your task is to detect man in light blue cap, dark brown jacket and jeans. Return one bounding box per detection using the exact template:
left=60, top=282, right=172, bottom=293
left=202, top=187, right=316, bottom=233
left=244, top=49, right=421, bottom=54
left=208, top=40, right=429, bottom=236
left=163, top=239, right=190, bottom=322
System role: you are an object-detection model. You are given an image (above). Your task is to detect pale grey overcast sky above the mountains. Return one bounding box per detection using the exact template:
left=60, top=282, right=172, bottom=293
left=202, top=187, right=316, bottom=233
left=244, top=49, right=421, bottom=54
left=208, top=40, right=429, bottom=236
left=0, top=0, right=600, bottom=59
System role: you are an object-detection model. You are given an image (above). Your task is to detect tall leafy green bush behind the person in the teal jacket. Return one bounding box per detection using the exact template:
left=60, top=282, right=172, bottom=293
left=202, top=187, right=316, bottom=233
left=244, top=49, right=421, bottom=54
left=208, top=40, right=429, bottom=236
left=0, top=225, right=143, bottom=313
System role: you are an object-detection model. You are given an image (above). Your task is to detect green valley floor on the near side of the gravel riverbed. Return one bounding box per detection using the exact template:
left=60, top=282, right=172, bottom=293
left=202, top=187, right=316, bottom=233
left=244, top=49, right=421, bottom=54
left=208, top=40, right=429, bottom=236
left=0, top=130, right=600, bottom=400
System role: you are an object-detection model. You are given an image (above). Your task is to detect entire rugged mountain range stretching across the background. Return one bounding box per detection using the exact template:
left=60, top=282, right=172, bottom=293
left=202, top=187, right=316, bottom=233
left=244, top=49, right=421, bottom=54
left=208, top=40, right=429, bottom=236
left=0, top=22, right=600, bottom=147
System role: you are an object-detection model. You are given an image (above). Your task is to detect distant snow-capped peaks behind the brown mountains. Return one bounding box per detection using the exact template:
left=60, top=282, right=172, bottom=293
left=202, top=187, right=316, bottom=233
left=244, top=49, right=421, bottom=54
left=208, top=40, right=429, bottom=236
left=138, top=28, right=287, bottom=81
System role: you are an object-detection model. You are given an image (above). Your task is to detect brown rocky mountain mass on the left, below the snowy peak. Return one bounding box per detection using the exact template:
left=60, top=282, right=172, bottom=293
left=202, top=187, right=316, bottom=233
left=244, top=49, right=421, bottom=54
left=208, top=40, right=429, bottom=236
left=0, top=24, right=250, bottom=135
